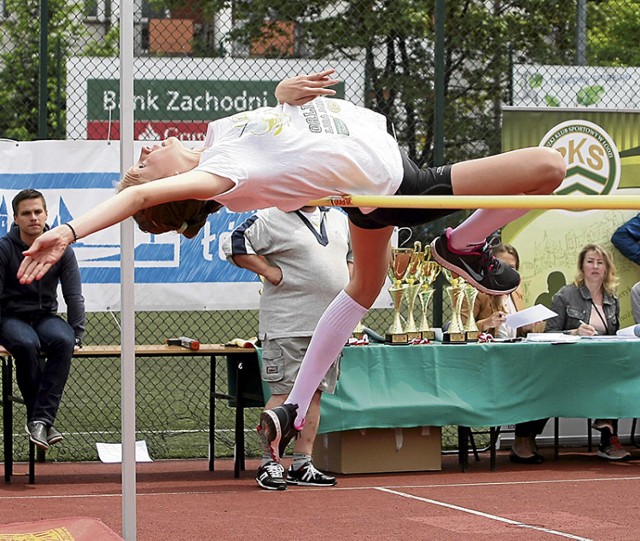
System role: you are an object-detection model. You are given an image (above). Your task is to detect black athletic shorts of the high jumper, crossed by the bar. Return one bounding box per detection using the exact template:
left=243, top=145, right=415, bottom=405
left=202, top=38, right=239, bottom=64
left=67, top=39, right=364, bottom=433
left=344, top=152, right=457, bottom=229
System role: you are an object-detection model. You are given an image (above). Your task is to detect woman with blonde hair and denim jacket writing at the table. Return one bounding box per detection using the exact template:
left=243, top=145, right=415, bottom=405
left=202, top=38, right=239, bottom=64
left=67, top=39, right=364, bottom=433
left=545, top=244, right=629, bottom=460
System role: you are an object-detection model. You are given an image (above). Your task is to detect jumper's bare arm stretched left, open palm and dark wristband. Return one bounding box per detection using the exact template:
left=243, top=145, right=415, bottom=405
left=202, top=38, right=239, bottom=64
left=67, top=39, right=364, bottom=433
left=18, top=171, right=233, bottom=284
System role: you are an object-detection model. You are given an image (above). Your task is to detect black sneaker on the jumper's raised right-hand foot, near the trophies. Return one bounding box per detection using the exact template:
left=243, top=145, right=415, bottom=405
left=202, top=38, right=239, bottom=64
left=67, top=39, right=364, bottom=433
left=431, top=228, right=520, bottom=295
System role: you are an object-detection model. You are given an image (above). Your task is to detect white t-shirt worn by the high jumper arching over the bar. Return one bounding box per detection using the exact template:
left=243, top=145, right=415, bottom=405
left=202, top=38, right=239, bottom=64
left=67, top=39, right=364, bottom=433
left=196, top=98, right=403, bottom=212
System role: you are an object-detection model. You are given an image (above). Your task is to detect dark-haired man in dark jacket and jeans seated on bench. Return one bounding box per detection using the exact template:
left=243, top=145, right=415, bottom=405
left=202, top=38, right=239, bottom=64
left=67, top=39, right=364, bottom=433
left=0, top=190, right=85, bottom=449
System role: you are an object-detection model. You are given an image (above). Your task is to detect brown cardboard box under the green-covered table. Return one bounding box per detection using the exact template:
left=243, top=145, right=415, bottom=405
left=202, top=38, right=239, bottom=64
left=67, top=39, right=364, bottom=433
left=313, top=426, right=442, bottom=473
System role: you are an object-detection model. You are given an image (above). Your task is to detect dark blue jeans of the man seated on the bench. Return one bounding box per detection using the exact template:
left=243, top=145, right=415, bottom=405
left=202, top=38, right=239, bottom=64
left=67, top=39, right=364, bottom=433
left=0, top=315, right=75, bottom=426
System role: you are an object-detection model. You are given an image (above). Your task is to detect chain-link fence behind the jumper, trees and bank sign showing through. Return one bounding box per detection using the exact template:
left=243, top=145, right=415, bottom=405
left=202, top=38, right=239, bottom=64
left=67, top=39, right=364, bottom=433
left=0, top=0, right=640, bottom=459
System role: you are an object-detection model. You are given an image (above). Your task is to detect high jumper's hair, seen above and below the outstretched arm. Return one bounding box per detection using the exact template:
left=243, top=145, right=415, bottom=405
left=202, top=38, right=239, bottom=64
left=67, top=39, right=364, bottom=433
left=116, top=170, right=222, bottom=239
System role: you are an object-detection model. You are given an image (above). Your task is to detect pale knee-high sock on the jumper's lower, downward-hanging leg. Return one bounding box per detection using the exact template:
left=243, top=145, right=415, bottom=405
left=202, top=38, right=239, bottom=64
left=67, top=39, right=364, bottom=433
left=286, top=291, right=367, bottom=429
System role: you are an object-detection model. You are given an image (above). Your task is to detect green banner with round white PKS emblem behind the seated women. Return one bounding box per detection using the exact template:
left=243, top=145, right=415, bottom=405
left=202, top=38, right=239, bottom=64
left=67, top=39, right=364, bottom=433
left=503, top=108, right=640, bottom=326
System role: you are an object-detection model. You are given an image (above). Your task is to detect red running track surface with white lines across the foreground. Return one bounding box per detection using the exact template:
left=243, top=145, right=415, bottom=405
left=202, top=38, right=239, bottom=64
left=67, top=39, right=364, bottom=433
left=0, top=450, right=640, bottom=541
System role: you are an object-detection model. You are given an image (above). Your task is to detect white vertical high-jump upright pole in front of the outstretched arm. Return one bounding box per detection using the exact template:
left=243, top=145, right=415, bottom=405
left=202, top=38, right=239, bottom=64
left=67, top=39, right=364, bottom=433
left=120, top=0, right=136, bottom=541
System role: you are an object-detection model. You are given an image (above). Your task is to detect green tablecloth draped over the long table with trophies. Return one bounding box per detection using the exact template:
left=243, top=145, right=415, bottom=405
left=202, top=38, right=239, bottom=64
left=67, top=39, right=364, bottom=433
left=319, top=340, right=640, bottom=433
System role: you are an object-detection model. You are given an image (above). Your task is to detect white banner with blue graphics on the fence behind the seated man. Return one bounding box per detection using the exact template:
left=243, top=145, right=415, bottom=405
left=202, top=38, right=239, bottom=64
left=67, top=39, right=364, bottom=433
left=0, top=141, right=390, bottom=312
